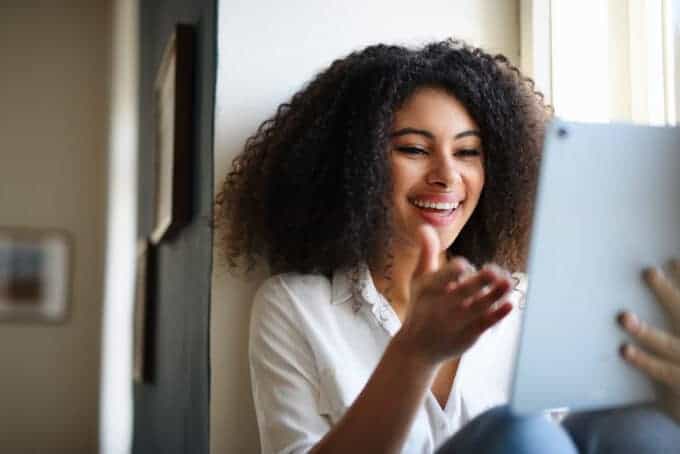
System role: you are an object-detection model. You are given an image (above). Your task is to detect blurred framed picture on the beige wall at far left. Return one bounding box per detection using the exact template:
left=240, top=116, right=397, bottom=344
left=0, top=227, right=73, bottom=322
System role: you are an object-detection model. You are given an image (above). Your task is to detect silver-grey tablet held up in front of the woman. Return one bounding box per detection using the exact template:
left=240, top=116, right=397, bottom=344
left=510, top=120, right=680, bottom=413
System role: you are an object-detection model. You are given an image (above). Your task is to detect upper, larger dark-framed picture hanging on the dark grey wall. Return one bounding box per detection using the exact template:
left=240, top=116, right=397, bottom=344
left=150, top=25, right=195, bottom=244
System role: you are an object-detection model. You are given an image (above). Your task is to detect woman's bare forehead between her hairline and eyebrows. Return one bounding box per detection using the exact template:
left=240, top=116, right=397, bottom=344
left=393, top=87, right=479, bottom=135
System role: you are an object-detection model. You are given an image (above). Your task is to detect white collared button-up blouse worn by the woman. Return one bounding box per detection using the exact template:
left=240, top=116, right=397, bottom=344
left=249, top=267, right=526, bottom=454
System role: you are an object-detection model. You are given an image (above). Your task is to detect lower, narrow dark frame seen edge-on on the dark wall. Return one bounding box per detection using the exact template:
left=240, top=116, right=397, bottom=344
left=133, top=239, right=155, bottom=383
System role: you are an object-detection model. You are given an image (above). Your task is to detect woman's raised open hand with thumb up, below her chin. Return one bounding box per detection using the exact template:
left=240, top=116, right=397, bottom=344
left=397, top=226, right=512, bottom=364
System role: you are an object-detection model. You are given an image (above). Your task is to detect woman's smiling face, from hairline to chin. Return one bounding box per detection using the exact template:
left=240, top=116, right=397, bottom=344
left=389, top=88, right=484, bottom=251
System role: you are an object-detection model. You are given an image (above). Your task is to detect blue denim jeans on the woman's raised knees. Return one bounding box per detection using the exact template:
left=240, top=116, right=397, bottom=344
left=437, top=406, right=680, bottom=454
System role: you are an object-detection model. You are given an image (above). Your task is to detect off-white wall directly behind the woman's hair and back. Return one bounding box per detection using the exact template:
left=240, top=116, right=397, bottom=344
left=210, top=0, right=519, bottom=453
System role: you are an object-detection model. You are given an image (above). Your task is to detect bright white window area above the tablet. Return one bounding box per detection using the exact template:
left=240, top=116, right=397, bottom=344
left=520, top=0, right=680, bottom=125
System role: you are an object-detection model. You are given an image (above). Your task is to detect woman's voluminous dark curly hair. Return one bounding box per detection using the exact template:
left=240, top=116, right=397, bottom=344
left=216, top=40, right=552, bottom=275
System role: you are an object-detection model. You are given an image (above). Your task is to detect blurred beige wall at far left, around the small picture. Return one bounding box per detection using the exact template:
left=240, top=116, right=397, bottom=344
left=0, top=0, right=110, bottom=454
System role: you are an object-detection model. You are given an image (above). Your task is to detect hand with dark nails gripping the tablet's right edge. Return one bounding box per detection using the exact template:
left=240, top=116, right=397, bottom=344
left=619, top=260, right=680, bottom=422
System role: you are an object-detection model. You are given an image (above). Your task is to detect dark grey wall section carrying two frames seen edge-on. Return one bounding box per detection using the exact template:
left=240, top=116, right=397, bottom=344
left=133, top=0, right=216, bottom=454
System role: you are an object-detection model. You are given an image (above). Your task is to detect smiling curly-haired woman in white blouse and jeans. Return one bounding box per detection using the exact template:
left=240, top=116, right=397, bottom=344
left=219, top=41, right=680, bottom=453
